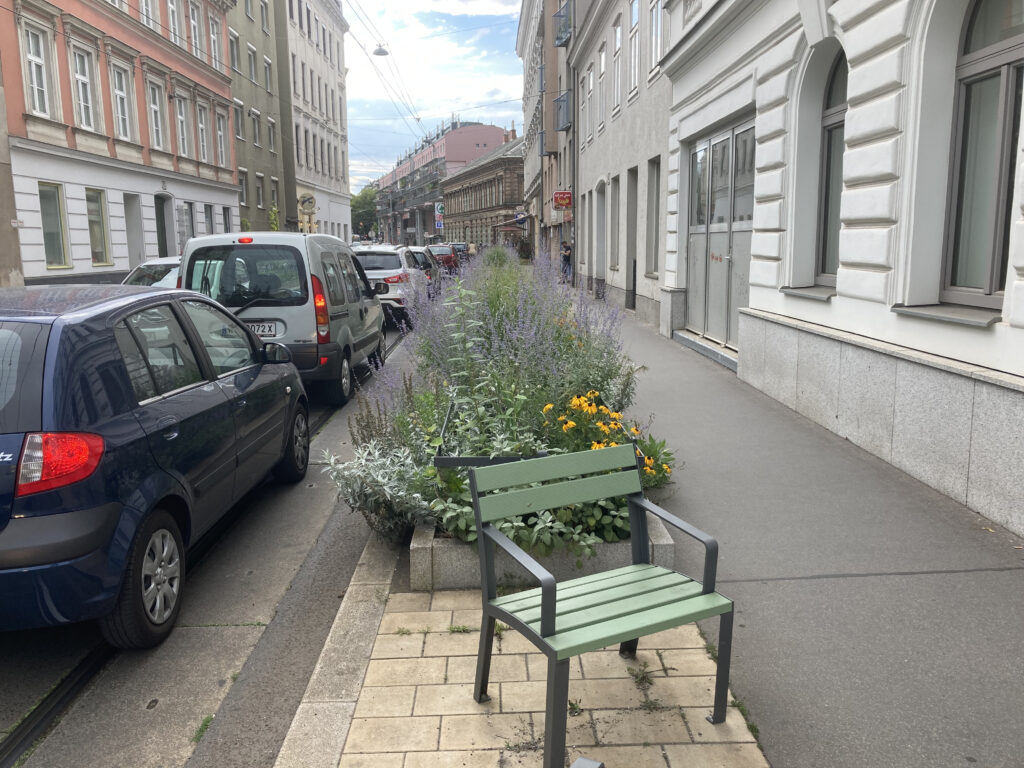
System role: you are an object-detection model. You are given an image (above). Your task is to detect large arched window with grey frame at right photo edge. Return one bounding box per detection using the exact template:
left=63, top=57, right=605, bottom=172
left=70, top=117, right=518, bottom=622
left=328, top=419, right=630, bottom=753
left=941, top=0, right=1024, bottom=307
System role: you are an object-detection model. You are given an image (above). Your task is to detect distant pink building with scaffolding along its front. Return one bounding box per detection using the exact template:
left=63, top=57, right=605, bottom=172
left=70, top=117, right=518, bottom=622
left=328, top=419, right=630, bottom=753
left=377, top=118, right=506, bottom=245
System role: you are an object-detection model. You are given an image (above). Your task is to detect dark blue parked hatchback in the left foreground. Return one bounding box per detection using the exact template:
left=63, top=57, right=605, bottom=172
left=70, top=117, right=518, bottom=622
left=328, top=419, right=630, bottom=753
left=0, top=286, right=309, bottom=648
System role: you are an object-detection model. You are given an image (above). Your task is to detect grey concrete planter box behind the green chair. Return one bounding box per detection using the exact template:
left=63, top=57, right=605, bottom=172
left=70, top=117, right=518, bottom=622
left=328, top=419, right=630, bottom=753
left=409, top=515, right=675, bottom=592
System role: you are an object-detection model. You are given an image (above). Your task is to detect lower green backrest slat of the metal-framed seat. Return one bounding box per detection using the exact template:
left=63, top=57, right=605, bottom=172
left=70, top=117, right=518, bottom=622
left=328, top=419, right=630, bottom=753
left=477, top=473, right=640, bottom=522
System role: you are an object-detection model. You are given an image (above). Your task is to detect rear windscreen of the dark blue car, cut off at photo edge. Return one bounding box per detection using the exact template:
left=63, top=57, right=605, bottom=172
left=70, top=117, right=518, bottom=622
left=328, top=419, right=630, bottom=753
left=0, top=321, right=50, bottom=434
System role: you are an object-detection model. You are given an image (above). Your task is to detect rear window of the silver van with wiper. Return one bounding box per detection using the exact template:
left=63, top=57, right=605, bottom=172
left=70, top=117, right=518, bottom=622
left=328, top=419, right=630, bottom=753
left=181, top=243, right=309, bottom=307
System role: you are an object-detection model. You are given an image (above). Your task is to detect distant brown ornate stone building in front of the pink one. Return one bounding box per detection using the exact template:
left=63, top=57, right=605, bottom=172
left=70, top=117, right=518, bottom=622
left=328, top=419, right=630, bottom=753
left=441, top=130, right=529, bottom=245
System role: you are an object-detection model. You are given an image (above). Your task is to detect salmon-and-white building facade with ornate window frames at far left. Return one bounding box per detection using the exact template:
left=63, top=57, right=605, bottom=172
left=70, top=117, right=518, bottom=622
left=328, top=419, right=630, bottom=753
left=0, top=0, right=239, bottom=283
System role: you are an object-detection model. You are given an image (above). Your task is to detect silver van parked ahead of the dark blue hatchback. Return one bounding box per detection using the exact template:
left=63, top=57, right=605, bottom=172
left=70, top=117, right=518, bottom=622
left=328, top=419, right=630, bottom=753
left=180, top=231, right=385, bottom=404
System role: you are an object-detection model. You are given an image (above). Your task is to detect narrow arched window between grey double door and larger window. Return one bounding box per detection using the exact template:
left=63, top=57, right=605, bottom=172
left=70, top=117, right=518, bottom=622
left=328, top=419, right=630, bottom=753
left=815, top=52, right=850, bottom=286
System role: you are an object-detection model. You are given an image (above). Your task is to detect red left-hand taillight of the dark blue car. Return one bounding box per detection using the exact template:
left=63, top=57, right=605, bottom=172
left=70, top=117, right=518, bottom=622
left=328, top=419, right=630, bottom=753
left=14, top=432, right=103, bottom=496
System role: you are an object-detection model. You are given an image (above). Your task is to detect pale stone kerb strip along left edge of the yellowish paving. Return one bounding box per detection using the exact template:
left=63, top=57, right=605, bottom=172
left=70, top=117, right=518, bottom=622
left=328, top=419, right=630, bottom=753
left=273, top=535, right=399, bottom=768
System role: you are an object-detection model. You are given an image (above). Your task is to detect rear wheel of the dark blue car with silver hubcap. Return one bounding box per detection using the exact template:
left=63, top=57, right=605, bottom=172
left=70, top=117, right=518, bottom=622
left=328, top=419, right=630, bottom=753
left=99, top=509, right=185, bottom=648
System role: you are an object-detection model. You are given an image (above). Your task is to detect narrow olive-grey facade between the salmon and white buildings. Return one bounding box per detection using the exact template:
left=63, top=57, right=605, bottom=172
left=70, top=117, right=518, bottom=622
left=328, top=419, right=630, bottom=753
left=227, top=0, right=286, bottom=230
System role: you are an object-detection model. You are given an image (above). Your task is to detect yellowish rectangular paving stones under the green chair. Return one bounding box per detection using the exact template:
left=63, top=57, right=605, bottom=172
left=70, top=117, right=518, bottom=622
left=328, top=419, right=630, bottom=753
left=331, top=591, right=768, bottom=768
